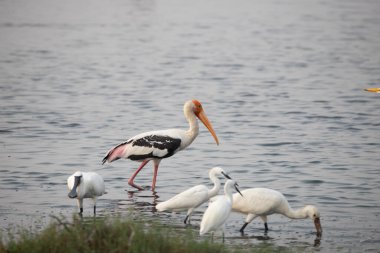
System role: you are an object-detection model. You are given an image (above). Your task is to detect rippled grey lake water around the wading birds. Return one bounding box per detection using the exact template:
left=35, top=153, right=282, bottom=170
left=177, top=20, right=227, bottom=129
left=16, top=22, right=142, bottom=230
left=0, top=0, right=380, bottom=252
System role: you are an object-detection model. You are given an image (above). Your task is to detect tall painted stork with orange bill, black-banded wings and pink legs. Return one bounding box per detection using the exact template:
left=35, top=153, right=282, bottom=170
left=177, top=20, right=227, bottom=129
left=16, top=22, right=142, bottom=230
left=103, top=99, right=219, bottom=191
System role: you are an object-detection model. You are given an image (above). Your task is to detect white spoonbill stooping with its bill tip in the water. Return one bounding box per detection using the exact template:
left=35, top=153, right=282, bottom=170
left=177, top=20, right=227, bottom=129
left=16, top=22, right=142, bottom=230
left=232, top=188, right=322, bottom=234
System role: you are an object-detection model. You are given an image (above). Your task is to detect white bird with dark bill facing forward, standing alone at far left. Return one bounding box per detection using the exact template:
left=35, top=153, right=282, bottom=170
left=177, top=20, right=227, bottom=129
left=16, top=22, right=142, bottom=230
left=67, top=171, right=105, bottom=214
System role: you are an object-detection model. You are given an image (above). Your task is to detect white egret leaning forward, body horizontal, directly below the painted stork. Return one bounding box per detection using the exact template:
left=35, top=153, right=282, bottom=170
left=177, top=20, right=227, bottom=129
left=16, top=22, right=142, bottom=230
left=156, top=167, right=231, bottom=224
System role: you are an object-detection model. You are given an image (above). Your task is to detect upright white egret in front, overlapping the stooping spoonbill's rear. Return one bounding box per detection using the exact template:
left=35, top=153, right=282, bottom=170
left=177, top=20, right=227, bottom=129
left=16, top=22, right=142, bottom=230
left=199, top=180, right=242, bottom=240
